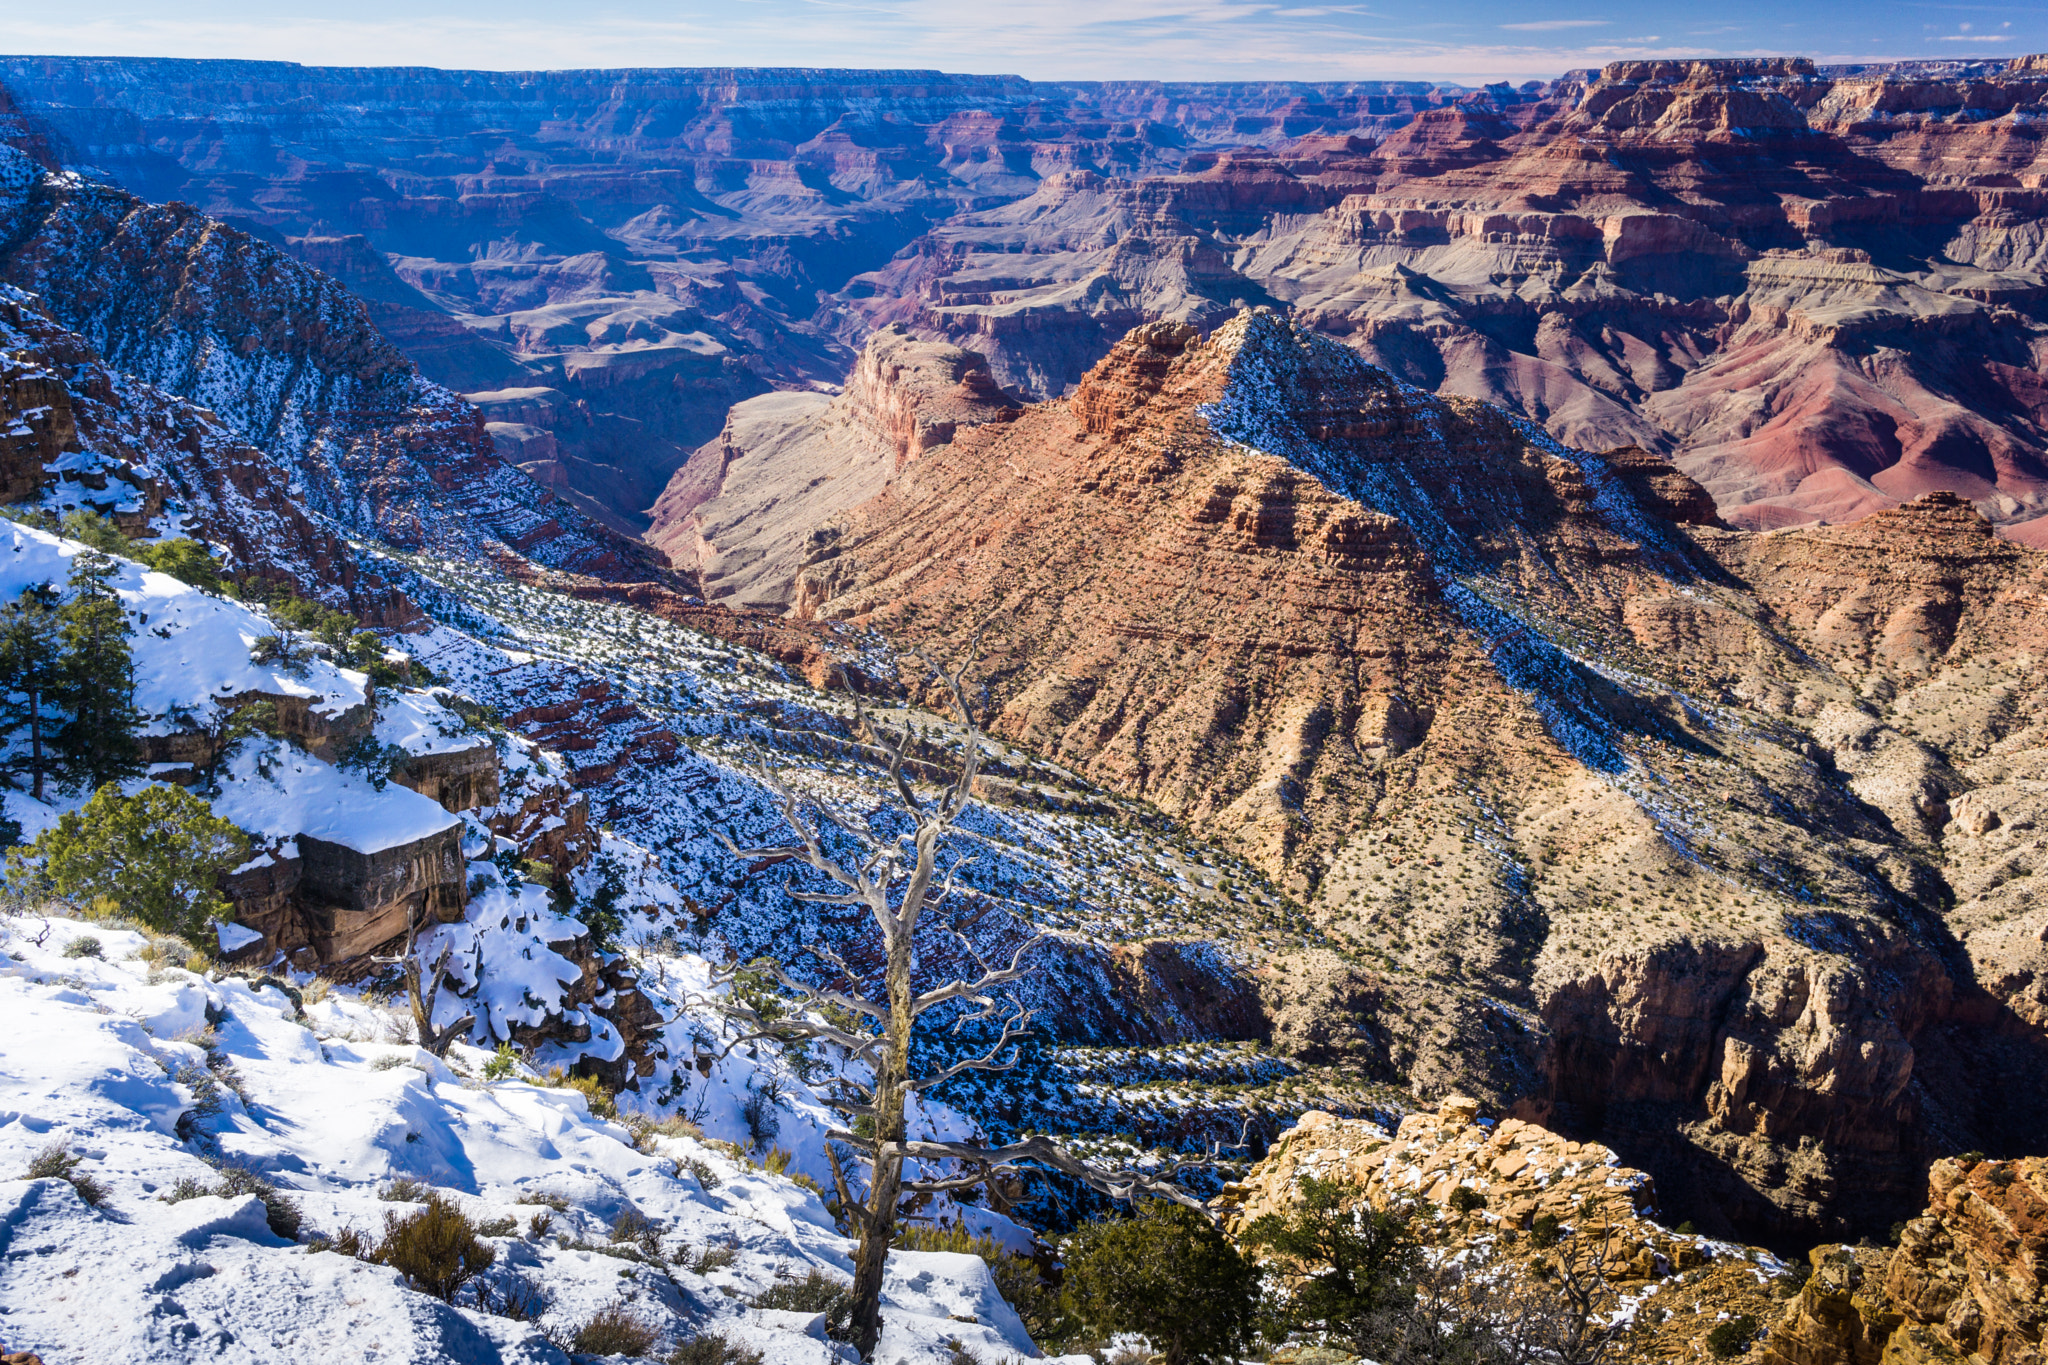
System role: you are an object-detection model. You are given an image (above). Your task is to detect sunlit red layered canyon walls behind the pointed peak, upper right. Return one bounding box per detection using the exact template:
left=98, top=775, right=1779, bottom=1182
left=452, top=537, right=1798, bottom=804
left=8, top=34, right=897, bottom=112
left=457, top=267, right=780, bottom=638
left=842, top=61, right=2048, bottom=536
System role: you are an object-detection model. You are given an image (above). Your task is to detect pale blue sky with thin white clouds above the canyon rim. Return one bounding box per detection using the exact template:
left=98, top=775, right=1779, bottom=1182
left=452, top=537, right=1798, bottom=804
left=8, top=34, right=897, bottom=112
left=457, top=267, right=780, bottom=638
left=0, top=0, right=2048, bottom=84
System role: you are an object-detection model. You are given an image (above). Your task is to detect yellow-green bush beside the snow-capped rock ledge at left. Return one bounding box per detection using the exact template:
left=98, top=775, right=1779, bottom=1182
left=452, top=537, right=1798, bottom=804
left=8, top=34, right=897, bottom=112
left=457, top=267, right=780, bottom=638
left=6, top=784, right=250, bottom=941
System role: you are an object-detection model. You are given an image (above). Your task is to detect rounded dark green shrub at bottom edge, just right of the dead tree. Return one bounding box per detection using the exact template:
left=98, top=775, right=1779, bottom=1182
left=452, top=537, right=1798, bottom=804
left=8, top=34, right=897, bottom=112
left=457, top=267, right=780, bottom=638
left=1061, top=1201, right=1260, bottom=1365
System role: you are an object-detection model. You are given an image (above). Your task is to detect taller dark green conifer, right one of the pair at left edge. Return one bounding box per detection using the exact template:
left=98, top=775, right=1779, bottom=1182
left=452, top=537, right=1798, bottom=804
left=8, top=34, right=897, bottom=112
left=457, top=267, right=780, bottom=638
left=57, top=551, right=141, bottom=790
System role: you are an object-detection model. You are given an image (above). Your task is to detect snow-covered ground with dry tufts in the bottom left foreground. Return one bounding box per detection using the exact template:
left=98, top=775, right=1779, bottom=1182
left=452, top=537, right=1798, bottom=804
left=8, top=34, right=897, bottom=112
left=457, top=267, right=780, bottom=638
left=0, top=917, right=1036, bottom=1365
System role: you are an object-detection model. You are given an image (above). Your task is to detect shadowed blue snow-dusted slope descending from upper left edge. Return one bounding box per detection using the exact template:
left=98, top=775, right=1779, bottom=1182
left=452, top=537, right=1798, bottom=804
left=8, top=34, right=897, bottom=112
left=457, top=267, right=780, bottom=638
left=0, top=149, right=649, bottom=577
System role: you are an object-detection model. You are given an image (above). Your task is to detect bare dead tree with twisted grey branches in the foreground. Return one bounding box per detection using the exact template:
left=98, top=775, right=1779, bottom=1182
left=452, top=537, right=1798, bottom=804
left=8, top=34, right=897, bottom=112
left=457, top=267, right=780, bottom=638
left=700, top=651, right=1219, bottom=1359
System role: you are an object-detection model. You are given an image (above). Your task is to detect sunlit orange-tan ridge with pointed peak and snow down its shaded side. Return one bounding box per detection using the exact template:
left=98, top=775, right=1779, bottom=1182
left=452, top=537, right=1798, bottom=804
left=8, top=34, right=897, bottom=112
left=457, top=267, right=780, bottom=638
left=774, top=313, right=2048, bottom=1240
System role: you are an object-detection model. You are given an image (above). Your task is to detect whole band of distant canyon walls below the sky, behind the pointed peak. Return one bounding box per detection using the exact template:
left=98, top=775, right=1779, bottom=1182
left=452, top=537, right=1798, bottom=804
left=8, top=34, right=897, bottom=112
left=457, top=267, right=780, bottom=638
left=0, top=57, right=2048, bottom=542
